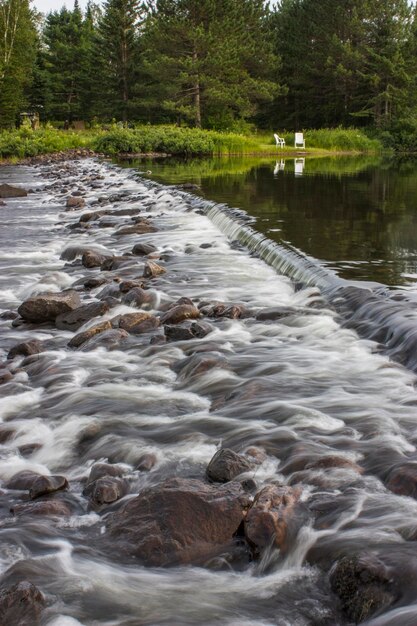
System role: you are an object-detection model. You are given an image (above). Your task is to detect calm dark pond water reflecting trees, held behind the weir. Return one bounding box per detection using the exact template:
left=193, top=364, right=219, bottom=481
left=119, top=156, right=417, bottom=290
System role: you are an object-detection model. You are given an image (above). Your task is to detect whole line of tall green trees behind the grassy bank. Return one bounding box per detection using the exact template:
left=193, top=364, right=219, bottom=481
left=0, top=0, right=417, bottom=141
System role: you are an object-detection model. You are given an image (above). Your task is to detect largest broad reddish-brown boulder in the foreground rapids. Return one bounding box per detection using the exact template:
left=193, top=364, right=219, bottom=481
left=107, top=478, right=250, bottom=567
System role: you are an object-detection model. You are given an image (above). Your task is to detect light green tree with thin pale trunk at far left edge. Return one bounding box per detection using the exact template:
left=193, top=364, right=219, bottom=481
left=0, top=0, right=37, bottom=128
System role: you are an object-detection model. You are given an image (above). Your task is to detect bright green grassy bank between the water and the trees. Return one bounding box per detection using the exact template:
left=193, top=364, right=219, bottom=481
left=0, top=126, right=382, bottom=159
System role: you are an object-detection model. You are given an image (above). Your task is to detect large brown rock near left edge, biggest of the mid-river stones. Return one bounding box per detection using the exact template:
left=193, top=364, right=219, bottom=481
left=18, top=291, right=81, bottom=323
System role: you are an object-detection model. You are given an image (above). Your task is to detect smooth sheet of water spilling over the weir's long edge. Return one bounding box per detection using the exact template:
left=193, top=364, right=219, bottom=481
left=185, top=193, right=417, bottom=372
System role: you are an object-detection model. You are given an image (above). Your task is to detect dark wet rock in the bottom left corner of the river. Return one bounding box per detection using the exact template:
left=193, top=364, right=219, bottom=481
left=0, top=580, right=45, bottom=626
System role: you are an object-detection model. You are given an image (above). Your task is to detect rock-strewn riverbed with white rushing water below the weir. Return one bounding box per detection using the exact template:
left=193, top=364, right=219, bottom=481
left=0, top=158, right=417, bottom=626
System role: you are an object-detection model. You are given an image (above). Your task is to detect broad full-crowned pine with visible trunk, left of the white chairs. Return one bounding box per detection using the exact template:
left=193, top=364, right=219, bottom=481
left=143, top=0, right=276, bottom=127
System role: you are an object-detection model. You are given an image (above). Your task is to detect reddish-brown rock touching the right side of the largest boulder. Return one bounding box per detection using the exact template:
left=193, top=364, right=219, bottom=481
left=244, top=485, right=300, bottom=557
